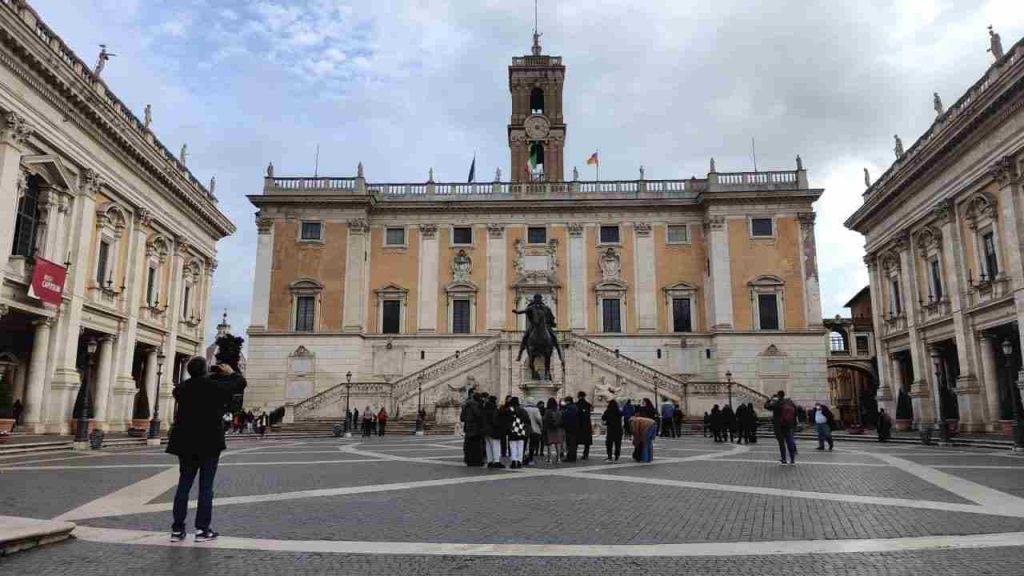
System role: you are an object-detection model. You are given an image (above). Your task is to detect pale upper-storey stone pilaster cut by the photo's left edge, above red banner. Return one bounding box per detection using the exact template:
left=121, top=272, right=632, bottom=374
left=0, top=112, right=33, bottom=270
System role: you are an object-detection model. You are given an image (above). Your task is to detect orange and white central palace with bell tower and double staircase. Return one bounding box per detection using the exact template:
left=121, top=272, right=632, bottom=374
left=246, top=38, right=826, bottom=419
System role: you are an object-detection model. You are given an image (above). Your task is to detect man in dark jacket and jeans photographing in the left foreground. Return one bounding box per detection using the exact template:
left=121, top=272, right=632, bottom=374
left=167, top=357, right=246, bottom=542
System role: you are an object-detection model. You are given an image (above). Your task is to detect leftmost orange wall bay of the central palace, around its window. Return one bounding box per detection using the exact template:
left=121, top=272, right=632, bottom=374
left=267, top=220, right=348, bottom=330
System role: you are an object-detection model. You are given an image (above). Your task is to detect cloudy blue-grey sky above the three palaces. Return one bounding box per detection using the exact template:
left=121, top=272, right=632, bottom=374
left=32, top=0, right=1024, bottom=340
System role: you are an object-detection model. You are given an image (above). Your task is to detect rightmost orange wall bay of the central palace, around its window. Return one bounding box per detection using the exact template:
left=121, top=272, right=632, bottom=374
left=727, top=216, right=807, bottom=330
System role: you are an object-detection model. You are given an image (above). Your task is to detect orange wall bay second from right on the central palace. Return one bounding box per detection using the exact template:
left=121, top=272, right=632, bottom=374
left=653, top=223, right=708, bottom=332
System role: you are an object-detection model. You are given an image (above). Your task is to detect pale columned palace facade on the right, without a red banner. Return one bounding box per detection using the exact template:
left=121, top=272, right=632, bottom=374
left=847, top=34, right=1024, bottom=431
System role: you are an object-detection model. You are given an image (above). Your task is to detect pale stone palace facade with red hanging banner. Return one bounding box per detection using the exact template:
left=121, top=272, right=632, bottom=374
left=0, top=0, right=234, bottom=434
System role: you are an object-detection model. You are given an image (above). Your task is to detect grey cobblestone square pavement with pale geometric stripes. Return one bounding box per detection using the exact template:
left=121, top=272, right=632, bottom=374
left=0, top=437, right=1024, bottom=576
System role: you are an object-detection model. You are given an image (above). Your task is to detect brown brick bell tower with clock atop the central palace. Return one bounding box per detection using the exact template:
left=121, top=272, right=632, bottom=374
left=509, top=30, right=565, bottom=182
